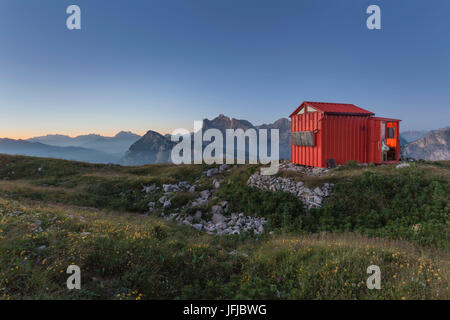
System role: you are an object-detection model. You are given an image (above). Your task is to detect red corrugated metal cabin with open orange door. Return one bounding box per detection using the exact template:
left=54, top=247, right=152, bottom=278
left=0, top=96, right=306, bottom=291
left=289, top=101, right=401, bottom=167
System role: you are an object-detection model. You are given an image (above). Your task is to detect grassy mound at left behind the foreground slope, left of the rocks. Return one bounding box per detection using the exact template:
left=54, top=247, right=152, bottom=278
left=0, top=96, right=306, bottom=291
left=0, top=155, right=214, bottom=213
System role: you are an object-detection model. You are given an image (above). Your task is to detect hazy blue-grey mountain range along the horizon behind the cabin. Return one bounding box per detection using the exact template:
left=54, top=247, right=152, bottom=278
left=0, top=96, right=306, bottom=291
left=0, top=114, right=450, bottom=165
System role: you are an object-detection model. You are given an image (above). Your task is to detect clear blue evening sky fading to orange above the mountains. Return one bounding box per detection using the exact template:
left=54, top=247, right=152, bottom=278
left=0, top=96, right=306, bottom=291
left=0, top=0, right=450, bottom=138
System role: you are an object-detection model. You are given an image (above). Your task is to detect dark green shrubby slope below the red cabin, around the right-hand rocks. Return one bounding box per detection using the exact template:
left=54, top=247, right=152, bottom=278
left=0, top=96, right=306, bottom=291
left=219, top=164, right=450, bottom=248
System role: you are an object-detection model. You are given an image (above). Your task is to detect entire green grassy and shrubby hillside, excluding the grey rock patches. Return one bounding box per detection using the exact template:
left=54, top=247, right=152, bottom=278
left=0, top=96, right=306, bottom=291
left=0, top=155, right=450, bottom=299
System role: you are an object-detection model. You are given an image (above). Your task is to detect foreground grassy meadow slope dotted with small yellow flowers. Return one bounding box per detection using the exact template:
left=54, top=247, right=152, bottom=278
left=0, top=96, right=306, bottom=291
left=0, top=199, right=450, bottom=300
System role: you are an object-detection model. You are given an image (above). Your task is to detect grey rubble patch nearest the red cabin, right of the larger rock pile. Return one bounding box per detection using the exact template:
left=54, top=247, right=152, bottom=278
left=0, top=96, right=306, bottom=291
left=247, top=173, right=334, bottom=209
